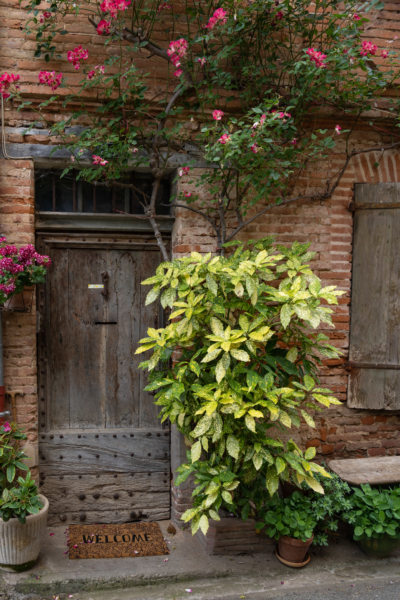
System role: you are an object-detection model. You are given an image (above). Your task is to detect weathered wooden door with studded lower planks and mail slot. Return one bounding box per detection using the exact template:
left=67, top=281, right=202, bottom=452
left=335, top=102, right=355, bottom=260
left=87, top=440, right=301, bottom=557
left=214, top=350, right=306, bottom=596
left=38, top=234, right=170, bottom=523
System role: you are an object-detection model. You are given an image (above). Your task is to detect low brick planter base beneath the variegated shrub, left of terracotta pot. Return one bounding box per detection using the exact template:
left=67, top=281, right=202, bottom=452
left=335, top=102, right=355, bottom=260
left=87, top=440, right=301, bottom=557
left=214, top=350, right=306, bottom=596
left=196, top=517, right=275, bottom=554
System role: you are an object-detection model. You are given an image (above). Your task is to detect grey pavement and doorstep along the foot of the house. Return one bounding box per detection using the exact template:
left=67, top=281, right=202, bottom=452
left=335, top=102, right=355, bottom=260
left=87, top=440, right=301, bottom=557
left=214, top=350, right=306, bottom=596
left=0, top=522, right=400, bottom=600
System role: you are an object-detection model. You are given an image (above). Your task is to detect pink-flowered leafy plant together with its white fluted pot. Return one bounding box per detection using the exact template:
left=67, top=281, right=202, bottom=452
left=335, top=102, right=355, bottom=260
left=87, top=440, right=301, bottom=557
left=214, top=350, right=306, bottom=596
left=0, top=423, right=49, bottom=571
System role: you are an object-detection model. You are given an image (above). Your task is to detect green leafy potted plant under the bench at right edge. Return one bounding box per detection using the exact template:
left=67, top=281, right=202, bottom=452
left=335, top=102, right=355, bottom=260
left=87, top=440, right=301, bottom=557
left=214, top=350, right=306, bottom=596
left=342, top=484, right=400, bottom=558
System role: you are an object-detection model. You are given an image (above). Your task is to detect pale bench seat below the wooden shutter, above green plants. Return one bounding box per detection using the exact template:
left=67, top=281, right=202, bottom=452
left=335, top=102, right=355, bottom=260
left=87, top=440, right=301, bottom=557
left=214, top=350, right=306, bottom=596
left=328, top=456, right=400, bottom=485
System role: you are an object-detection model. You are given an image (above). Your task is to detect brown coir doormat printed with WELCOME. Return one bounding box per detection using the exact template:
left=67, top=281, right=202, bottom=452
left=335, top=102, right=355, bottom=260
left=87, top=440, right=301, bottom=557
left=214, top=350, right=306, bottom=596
left=68, top=523, right=169, bottom=559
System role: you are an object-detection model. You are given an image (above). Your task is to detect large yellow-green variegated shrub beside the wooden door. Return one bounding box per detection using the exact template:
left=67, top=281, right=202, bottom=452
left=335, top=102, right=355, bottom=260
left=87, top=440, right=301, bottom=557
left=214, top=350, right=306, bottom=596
left=136, top=239, right=340, bottom=534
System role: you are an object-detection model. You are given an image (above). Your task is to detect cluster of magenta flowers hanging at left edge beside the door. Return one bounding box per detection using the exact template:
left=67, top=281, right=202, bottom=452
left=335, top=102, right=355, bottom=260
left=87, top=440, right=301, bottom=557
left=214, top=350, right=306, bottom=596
left=0, top=236, right=51, bottom=310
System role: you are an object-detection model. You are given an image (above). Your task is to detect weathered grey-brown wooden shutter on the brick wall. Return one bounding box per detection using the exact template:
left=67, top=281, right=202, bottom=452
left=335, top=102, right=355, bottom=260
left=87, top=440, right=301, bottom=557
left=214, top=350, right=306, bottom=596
left=348, top=183, right=400, bottom=410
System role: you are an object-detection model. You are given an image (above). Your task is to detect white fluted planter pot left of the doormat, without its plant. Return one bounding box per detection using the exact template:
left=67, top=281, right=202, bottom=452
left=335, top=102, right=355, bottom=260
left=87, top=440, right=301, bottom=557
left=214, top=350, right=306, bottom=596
left=0, top=494, right=49, bottom=571
